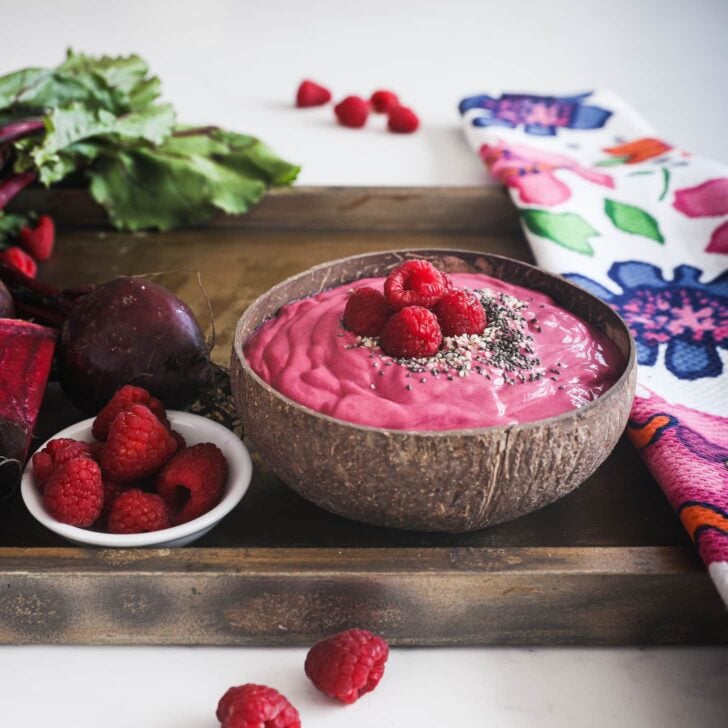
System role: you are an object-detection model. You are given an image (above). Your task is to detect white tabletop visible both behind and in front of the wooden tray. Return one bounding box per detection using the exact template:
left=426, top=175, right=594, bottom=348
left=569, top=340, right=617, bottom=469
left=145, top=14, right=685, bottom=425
left=0, top=0, right=728, bottom=728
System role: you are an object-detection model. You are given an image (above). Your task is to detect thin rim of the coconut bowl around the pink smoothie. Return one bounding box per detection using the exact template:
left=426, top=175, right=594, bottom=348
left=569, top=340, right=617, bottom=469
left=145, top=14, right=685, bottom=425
left=233, top=248, right=636, bottom=438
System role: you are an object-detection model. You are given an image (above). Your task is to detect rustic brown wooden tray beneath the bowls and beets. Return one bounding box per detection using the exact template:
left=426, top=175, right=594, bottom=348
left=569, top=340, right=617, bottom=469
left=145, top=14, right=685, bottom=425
left=0, top=188, right=728, bottom=645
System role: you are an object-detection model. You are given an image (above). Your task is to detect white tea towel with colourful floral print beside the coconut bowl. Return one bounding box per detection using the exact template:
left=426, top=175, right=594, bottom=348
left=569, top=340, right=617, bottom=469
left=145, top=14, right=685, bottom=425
left=460, top=91, right=728, bottom=603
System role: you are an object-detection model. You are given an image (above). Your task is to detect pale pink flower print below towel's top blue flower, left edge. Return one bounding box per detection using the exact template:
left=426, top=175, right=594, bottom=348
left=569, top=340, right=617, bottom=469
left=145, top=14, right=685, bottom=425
left=480, top=142, right=614, bottom=206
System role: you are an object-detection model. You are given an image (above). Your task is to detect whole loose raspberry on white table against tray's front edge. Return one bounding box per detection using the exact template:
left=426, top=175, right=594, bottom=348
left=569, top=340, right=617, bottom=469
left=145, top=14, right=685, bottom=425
left=305, top=629, right=389, bottom=703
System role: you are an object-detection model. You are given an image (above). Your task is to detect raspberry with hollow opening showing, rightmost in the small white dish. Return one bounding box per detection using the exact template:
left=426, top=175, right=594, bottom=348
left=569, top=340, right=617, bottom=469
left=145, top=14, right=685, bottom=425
left=156, top=442, right=228, bottom=524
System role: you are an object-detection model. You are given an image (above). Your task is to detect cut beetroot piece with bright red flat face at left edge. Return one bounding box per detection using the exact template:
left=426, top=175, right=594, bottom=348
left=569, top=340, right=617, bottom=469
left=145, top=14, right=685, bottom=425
left=0, top=319, right=56, bottom=495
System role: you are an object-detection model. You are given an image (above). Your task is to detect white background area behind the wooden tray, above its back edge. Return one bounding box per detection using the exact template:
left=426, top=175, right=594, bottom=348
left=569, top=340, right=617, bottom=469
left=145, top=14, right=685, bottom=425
left=0, top=0, right=728, bottom=185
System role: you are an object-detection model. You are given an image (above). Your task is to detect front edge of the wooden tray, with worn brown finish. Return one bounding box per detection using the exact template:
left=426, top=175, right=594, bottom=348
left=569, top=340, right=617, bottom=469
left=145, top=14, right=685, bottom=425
left=0, top=547, right=728, bottom=646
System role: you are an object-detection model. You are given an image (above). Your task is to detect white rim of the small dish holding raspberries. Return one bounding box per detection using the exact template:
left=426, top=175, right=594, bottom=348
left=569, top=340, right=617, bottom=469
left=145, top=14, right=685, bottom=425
left=20, top=410, right=253, bottom=548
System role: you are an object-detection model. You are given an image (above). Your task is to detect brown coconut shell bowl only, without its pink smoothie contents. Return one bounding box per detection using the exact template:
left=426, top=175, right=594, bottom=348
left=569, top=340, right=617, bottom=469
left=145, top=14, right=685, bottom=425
left=231, top=250, right=636, bottom=533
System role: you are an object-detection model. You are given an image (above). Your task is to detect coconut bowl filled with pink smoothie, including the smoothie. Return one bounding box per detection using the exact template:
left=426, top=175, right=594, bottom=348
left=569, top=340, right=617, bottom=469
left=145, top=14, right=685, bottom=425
left=231, top=250, right=636, bottom=532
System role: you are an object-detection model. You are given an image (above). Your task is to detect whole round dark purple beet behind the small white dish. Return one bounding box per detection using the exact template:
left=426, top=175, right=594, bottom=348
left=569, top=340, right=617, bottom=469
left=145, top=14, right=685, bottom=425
left=58, top=278, right=212, bottom=413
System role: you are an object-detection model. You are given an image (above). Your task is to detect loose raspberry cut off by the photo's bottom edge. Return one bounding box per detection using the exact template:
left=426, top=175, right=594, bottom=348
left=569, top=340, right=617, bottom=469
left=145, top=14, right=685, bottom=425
left=216, top=683, right=301, bottom=728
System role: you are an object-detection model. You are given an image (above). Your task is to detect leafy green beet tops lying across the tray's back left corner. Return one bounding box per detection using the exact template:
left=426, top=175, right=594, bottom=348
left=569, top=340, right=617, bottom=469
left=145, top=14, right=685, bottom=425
left=0, top=51, right=299, bottom=244
